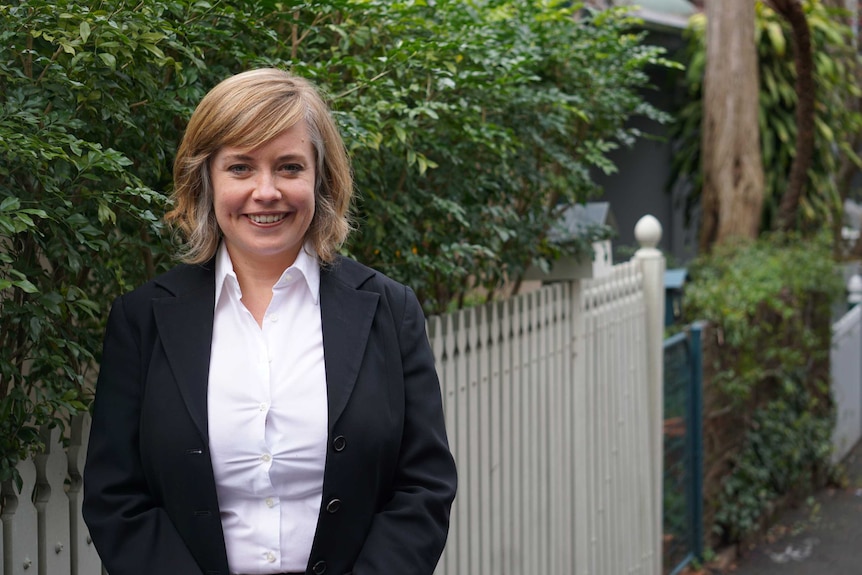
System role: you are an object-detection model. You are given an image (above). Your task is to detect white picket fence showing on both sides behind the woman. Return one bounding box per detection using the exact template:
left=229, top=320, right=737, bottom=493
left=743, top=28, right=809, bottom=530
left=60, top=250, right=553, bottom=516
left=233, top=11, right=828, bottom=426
left=0, top=216, right=664, bottom=575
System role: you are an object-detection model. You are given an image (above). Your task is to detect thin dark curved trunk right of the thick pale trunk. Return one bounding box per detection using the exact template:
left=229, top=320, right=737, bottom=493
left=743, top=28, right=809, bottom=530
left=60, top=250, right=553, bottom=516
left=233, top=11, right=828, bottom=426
left=769, top=0, right=815, bottom=231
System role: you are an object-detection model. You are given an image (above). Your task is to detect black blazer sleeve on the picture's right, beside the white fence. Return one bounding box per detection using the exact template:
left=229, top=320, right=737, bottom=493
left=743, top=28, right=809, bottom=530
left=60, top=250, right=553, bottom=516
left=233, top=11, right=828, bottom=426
left=352, top=287, right=457, bottom=575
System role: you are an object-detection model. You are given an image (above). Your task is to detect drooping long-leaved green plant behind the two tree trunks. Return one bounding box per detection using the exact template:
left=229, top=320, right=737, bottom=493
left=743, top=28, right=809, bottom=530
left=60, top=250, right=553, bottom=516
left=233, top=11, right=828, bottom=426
left=673, top=0, right=862, bottom=234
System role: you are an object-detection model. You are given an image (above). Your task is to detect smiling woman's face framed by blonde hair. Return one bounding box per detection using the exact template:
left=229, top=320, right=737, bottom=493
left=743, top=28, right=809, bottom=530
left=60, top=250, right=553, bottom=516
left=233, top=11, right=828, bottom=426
left=210, top=122, right=315, bottom=273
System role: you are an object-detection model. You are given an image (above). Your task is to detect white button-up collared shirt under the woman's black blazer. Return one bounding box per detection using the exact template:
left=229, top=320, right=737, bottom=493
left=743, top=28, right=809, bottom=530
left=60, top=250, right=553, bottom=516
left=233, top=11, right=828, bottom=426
left=208, top=244, right=327, bottom=574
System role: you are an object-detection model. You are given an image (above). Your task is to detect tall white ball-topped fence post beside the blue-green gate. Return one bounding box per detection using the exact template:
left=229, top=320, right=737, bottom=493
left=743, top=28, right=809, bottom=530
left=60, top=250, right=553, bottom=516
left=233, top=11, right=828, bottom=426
left=634, top=215, right=665, bottom=574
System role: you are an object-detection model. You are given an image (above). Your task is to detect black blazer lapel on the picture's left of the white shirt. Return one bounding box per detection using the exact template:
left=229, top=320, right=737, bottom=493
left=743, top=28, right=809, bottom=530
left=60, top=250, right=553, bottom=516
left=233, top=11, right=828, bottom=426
left=153, top=261, right=215, bottom=442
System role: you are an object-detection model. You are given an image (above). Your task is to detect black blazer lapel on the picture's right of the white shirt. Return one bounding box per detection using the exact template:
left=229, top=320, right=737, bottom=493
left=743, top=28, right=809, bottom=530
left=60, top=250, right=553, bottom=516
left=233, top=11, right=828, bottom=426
left=320, top=260, right=380, bottom=432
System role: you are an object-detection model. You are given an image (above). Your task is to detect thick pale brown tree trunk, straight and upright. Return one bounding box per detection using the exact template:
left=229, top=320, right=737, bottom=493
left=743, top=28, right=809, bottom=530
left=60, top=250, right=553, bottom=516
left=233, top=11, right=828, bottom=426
left=700, top=0, right=764, bottom=251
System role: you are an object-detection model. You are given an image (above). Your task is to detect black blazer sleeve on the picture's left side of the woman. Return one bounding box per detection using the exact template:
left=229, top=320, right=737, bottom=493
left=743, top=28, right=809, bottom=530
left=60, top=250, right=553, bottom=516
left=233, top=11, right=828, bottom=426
left=83, top=298, right=207, bottom=575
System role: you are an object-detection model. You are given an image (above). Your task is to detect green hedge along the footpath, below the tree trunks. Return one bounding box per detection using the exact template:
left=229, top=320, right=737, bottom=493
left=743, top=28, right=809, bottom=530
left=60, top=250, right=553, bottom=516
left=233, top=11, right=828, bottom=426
left=686, top=232, right=843, bottom=542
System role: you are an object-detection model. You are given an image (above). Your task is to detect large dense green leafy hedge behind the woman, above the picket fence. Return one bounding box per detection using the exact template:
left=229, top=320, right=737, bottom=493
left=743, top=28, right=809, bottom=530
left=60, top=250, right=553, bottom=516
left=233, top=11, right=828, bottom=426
left=0, top=0, right=669, bottom=486
